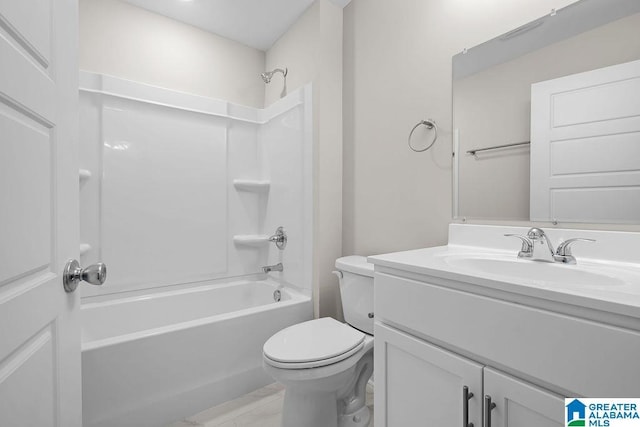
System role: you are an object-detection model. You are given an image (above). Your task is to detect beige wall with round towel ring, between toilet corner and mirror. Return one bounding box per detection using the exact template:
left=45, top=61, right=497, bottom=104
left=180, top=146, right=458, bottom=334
left=343, top=0, right=574, bottom=255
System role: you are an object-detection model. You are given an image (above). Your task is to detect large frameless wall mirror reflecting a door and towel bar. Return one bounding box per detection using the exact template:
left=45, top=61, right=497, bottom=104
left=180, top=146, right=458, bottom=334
left=453, top=0, right=640, bottom=224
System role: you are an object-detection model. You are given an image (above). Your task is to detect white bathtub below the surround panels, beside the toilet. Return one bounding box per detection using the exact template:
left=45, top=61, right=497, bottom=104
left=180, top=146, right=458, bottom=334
left=81, top=280, right=313, bottom=427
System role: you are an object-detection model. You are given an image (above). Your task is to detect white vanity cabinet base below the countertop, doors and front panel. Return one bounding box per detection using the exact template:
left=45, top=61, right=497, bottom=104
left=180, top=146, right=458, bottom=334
left=374, top=270, right=640, bottom=427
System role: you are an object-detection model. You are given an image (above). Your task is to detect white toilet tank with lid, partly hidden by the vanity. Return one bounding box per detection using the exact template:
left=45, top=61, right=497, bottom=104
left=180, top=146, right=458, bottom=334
left=336, top=255, right=373, bottom=335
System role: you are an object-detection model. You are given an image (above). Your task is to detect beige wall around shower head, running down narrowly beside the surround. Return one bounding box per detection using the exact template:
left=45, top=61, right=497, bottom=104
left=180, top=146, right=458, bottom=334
left=265, top=0, right=343, bottom=319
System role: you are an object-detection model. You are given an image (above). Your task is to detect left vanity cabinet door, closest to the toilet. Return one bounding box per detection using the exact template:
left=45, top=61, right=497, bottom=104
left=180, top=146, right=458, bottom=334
left=375, top=323, right=482, bottom=427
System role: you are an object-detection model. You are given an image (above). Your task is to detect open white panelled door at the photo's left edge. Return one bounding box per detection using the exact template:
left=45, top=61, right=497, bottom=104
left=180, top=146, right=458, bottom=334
left=0, top=0, right=82, bottom=427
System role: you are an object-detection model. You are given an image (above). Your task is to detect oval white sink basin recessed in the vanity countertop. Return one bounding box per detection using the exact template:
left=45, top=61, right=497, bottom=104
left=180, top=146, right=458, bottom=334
left=444, top=255, right=625, bottom=288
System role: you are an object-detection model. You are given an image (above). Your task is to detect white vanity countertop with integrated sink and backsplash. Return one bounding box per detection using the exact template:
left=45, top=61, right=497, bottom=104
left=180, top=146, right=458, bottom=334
left=369, top=224, right=640, bottom=320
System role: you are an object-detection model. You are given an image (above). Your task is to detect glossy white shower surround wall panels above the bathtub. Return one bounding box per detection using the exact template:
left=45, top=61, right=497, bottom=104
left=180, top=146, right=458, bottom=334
left=80, top=72, right=313, bottom=297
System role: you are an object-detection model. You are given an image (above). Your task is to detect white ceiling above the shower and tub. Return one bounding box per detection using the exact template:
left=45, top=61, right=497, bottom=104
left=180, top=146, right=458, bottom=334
left=124, top=0, right=350, bottom=50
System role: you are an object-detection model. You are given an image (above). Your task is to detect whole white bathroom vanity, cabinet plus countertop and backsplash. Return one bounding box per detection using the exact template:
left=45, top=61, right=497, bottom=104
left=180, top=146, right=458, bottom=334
left=369, top=224, right=640, bottom=426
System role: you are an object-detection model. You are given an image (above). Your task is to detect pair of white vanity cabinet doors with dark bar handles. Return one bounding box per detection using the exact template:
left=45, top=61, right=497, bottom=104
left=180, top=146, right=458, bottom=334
left=375, top=323, right=564, bottom=427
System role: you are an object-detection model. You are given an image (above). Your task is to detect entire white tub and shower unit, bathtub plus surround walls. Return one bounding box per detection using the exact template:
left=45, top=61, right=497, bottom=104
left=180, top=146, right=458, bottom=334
left=80, top=70, right=313, bottom=426
